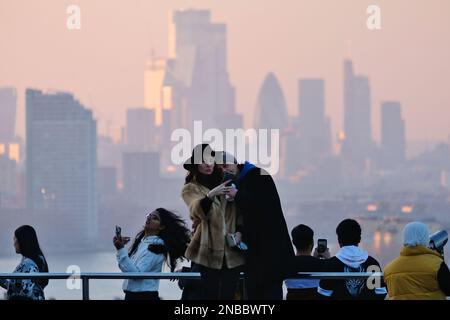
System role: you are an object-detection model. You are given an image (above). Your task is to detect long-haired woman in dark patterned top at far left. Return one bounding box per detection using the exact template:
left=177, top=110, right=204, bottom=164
left=0, top=226, right=48, bottom=300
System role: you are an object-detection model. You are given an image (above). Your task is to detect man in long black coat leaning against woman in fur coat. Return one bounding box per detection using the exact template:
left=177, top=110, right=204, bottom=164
left=220, top=157, right=295, bottom=300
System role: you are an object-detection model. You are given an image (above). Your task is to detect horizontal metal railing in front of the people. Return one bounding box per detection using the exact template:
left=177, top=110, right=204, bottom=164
left=0, top=272, right=383, bottom=300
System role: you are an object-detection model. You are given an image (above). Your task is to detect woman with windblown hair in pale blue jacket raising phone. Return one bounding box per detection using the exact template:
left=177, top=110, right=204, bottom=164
left=113, top=208, right=190, bottom=300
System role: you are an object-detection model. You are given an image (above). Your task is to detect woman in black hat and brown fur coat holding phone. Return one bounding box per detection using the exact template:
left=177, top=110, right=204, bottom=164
left=182, top=144, right=244, bottom=300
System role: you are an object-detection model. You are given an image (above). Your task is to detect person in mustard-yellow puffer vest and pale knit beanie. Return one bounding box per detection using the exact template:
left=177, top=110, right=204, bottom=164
left=384, top=221, right=450, bottom=300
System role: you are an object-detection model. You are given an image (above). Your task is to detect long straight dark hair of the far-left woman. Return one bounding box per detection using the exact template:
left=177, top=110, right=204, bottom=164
left=14, top=226, right=48, bottom=288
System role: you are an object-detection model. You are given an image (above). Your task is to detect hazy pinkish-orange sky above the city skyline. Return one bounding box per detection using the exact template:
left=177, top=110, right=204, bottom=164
left=0, top=0, right=450, bottom=139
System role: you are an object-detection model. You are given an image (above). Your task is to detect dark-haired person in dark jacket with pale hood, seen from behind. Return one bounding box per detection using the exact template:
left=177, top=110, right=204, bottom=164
left=317, top=219, right=387, bottom=300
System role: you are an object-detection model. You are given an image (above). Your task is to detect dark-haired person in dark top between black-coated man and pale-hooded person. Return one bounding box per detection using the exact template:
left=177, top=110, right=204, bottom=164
left=285, top=224, right=330, bottom=300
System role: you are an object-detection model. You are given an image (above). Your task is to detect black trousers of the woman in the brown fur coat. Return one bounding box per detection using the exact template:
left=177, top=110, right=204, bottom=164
left=200, top=263, right=241, bottom=300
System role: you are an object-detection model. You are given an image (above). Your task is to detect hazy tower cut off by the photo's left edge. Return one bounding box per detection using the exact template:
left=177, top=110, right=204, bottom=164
left=0, top=88, right=17, bottom=144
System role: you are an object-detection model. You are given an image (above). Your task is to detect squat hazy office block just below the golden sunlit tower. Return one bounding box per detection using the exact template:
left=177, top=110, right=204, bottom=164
left=126, top=108, right=158, bottom=151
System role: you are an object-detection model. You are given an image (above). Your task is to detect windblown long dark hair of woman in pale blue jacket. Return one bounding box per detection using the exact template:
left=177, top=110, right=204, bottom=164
left=129, top=208, right=191, bottom=272
